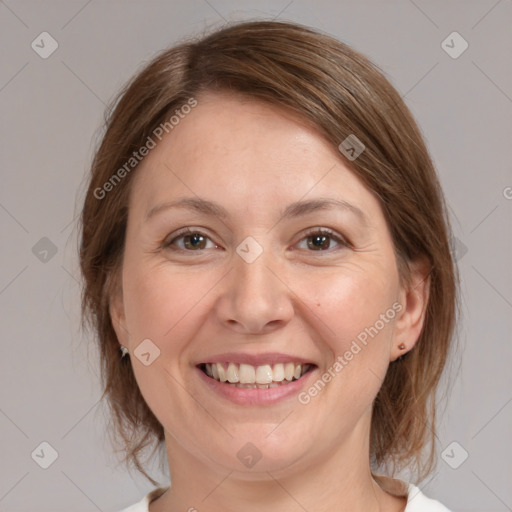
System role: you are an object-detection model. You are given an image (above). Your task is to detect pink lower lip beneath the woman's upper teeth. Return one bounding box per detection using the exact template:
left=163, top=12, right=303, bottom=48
left=196, top=368, right=316, bottom=405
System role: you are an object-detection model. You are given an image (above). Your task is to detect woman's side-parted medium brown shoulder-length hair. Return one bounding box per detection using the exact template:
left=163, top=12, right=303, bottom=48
left=80, top=21, right=458, bottom=484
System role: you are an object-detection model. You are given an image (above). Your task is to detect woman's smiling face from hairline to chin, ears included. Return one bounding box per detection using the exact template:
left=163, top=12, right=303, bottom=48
left=111, top=94, right=428, bottom=478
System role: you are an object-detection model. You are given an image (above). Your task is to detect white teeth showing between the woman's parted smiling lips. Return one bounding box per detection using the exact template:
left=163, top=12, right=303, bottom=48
left=198, top=362, right=316, bottom=389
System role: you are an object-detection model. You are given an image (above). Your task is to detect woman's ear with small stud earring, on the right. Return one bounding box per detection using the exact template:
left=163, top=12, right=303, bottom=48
left=390, top=259, right=432, bottom=361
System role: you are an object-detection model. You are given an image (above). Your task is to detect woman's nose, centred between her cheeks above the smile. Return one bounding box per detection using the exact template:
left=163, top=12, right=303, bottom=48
left=216, top=246, right=294, bottom=334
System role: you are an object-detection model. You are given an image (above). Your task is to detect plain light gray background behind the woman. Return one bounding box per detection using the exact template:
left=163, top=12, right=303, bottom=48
left=0, top=0, right=512, bottom=512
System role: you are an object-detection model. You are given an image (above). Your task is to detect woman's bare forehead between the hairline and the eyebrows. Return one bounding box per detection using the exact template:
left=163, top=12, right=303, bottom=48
left=128, top=93, right=376, bottom=222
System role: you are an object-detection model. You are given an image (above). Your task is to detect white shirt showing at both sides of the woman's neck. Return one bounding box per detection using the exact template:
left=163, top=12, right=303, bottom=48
left=120, top=477, right=450, bottom=512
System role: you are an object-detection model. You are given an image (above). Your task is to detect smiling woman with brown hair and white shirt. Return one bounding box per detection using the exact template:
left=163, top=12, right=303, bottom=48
left=80, top=22, right=457, bottom=512
